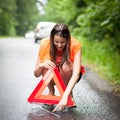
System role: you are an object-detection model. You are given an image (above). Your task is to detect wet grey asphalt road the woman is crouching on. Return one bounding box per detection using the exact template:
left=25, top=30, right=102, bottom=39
left=0, top=38, right=120, bottom=120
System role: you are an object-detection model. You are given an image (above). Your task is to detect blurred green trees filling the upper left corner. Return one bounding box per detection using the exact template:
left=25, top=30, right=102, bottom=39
left=0, top=0, right=39, bottom=36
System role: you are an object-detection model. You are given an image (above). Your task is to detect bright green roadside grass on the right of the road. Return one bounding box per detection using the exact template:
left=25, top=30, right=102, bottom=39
left=77, top=36, right=120, bottom=92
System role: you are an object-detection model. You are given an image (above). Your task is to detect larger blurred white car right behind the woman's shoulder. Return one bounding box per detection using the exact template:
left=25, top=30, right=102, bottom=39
left=35, top=22, right=56, bottom=43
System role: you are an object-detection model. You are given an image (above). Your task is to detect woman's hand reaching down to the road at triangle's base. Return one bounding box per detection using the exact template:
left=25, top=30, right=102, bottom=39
left=52, top=95, right=68, bottom=112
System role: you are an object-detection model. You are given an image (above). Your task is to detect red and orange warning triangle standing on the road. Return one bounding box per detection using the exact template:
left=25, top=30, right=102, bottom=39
left=28, top=68, right=75, bottom=106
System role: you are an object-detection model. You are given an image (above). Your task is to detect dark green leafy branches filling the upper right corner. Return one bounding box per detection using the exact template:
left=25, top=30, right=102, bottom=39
left=76, top=0, right=120, bottom=51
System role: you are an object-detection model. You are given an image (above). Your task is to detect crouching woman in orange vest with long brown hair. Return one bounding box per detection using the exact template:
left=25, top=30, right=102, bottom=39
left=34, top=24, right=81, bottom=112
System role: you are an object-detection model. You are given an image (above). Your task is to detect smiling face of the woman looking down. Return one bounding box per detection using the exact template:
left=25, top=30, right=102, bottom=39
left=54, top=35, right=67, bottom=50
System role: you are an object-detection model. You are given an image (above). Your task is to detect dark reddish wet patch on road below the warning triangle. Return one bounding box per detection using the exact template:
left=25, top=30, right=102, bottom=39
left=27, top=105, right=80, bottom=120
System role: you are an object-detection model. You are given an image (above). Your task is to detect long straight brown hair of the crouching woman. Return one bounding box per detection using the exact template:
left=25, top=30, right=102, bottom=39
left=50, top=24, right=71, bottom=67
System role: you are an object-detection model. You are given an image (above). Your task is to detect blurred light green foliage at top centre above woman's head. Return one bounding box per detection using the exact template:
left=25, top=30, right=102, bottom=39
left=45, top=0, right=84, bottom=25
